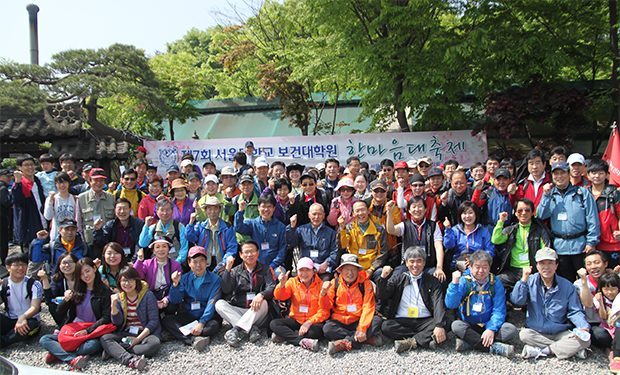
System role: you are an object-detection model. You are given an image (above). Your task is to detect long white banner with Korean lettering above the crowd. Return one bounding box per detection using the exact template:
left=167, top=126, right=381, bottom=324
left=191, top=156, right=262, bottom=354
left=144, top=130, right=487, bottom=175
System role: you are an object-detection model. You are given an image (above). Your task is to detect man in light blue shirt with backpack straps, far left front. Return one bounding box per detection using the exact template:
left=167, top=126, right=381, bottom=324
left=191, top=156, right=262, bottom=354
left=0, top=253, right=43, bottom=348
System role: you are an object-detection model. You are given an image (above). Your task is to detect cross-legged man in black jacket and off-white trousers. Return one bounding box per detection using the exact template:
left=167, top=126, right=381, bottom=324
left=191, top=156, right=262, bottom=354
left=215, top=241, right=275, bottom=347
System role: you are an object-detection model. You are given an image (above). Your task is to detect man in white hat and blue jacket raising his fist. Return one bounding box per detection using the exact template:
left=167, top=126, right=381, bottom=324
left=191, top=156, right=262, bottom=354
left=186, top=197, right=237, bottom=273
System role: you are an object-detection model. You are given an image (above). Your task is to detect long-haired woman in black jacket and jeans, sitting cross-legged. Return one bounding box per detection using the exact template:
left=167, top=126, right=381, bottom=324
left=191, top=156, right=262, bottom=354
left=39, top=258, right=112, bottom=370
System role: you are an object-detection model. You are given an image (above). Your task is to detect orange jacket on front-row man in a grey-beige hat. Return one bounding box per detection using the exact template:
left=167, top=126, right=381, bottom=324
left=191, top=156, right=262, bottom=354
left=321, top=270, right=375, bottom=332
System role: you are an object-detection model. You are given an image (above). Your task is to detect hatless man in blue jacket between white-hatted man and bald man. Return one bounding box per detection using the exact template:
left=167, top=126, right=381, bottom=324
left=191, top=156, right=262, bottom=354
left=235, top=195, right=286, bottom=270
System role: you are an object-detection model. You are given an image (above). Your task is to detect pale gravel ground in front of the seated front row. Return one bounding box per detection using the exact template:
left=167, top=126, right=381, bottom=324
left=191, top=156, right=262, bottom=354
left=0, top=306, right=607, bottom=375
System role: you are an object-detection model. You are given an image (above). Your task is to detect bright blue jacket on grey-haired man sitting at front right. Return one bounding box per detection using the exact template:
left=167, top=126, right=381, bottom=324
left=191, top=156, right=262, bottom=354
left=446, top=275, right=506, bottom=332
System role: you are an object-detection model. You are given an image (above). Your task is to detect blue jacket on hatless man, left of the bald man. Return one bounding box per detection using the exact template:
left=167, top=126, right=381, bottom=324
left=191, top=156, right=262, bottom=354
left=235, top=211, right=286, bottom=269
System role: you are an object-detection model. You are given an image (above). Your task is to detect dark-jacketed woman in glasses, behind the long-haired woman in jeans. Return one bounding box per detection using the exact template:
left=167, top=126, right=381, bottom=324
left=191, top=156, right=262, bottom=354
left=37, top=253, right=78, bottom=327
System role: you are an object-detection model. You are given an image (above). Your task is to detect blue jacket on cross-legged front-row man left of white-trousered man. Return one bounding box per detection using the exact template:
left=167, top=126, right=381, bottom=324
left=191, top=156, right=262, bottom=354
left=168, top=271, right=222, bottom=324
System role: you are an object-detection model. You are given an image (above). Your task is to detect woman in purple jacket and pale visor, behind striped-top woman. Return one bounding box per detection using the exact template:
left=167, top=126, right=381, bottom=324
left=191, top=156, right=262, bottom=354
left=133, top=236, right=182, bottom=314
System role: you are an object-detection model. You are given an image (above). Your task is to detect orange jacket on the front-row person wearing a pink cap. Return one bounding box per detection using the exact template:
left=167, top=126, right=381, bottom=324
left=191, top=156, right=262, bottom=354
left=273, top=275, right=329, bottom=324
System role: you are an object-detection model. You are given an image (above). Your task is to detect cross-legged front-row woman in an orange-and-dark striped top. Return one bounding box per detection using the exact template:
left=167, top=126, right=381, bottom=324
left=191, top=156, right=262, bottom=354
left=101, top=267, right=161, bottom=371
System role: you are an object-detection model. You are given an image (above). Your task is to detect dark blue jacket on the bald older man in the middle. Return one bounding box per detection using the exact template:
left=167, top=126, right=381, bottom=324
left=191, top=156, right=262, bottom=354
left=286, top=223, right=338, bottom=271
